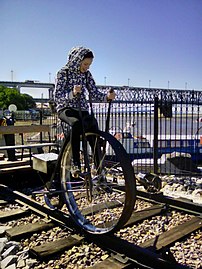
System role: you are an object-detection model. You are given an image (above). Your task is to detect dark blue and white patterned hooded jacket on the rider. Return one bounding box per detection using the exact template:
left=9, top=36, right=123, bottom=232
left=54, top=47, right=106, bottom=112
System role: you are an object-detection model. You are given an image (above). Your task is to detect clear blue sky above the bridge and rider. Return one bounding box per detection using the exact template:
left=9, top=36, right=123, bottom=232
left=0, top=0, right=202, bottom=98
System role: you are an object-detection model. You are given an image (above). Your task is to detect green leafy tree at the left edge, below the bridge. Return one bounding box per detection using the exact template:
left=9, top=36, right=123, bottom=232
left=0, top=85, right=36, bottom=110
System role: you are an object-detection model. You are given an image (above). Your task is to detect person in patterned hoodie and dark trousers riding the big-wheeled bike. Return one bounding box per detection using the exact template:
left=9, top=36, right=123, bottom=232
left=54, top=47, right=115, bottom=173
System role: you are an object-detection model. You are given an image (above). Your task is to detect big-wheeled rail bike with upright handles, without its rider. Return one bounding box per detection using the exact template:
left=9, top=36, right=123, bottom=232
left=35, top=90, right=136, bottom=234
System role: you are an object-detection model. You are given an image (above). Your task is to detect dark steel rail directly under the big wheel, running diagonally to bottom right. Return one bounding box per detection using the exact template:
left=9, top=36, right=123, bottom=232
left=0, top=184, right=191, bottom=269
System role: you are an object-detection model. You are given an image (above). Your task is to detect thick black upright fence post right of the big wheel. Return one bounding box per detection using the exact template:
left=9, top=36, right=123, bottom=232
left=153, top=97, right=159, bottom=174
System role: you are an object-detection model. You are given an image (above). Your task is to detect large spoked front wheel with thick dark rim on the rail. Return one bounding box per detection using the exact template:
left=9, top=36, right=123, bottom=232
left=61, top=131, right=136, bottom=234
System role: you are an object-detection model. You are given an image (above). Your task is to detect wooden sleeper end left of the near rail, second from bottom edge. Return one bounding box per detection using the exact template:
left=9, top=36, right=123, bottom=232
left=30, top=235, right=83, bottom=258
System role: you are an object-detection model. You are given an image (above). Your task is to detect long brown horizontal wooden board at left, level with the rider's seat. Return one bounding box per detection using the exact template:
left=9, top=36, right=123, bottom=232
left=0, top=125, right=50, bottom=134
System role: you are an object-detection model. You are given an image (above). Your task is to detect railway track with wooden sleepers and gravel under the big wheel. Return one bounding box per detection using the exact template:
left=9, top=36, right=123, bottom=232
left=0, top=182, right=202, bottom=269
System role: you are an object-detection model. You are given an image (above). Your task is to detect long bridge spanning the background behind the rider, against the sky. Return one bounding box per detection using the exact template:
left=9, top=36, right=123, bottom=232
left=0, top=80, right=202, bottom=104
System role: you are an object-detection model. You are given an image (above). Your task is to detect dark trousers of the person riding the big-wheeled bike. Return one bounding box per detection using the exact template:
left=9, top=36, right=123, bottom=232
left=58, top=108, right=98, bottom=167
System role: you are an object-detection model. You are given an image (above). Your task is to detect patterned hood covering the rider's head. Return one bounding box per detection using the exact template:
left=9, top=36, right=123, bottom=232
left=65, top=47, right=91, bottom=71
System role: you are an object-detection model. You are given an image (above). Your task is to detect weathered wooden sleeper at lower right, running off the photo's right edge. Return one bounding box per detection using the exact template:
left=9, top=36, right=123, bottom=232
left=140, top=217, right=202, bottom=251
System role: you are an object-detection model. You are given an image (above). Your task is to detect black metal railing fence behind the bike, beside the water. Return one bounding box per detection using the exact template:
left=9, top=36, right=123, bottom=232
left=15, top=87, right=202, bottom=175
